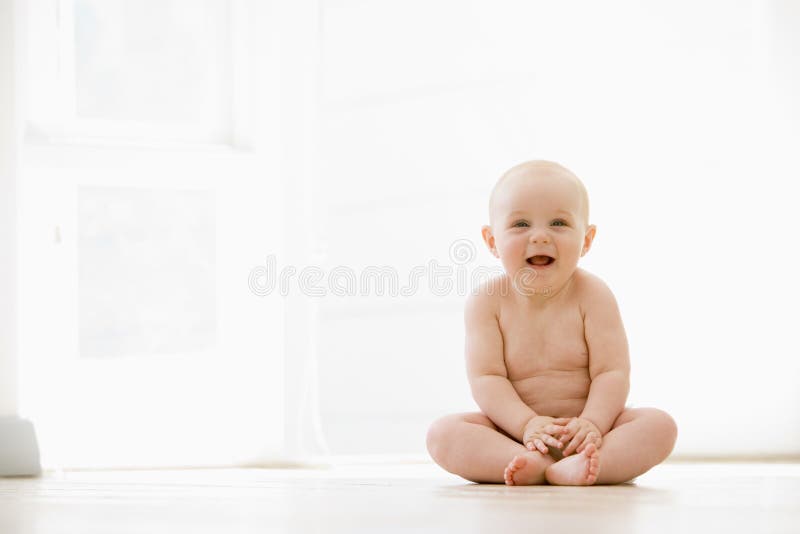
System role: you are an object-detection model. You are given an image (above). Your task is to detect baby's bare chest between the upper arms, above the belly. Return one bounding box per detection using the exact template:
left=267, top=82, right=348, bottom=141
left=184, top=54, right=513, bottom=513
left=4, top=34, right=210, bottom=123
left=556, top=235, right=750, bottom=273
left=500, top=310, right=589, bottom=381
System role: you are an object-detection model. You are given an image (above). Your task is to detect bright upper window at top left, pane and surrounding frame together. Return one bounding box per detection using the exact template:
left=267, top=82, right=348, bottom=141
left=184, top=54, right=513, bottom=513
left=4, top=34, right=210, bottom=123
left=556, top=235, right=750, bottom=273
left=27, top=0, right=235, bottom=144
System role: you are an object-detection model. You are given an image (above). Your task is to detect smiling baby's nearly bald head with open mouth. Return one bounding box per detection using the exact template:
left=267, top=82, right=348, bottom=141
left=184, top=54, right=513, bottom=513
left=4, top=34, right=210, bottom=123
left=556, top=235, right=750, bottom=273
left=482, top=160, right=596, bottom=296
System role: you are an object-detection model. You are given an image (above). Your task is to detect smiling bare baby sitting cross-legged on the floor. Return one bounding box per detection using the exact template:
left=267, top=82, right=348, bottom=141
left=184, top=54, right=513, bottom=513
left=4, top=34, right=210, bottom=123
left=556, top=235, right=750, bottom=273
left=427, top=161, right=677, bottom=485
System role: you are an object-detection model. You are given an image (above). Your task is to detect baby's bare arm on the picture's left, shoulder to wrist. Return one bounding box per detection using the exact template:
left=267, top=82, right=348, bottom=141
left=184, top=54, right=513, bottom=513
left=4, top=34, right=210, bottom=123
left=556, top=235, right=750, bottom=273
left=464, top=287, right=536, bottom=441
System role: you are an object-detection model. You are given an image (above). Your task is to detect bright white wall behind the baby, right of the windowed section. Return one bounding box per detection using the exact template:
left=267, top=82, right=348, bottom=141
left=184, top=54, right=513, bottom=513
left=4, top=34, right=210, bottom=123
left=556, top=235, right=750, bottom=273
left=316, top=0, right=800, bottom=460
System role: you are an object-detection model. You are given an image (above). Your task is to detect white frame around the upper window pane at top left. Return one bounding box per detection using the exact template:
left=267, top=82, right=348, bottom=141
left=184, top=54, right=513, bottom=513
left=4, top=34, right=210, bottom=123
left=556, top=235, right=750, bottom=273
left=22, top=0, right=254, bottom=150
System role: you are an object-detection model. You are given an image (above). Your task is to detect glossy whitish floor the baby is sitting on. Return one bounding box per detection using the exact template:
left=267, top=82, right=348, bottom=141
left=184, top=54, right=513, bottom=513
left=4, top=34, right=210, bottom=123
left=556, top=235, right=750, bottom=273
left=0, top=463, right=800, bottom=534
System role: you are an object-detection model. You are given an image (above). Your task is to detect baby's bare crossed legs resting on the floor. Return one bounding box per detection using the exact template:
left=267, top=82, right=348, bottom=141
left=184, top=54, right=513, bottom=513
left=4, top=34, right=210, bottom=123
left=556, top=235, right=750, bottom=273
left=427, top=408, right=677, bottom=484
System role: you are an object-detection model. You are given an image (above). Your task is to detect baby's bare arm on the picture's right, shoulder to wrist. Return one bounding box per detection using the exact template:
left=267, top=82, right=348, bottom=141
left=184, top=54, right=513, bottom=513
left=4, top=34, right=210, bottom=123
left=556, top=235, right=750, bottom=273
left=564, top=278, right=630, bottom=454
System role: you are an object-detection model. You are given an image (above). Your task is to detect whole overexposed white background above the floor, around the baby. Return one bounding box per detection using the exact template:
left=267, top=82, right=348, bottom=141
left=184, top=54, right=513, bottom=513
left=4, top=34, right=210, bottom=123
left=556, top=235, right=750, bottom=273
left=0, top=0, right=800, bottom=467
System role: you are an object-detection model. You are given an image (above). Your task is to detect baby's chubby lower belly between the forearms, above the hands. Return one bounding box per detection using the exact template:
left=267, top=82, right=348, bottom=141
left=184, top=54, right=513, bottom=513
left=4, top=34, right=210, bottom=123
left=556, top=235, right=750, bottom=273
left=509, top=368, right=591, bottom=417
